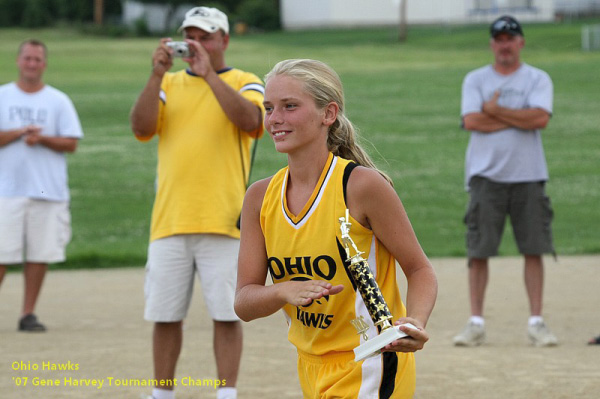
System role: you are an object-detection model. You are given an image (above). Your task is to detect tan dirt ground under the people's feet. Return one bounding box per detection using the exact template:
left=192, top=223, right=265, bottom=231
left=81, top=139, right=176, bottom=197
left=0, top=256, right=600, bottom=399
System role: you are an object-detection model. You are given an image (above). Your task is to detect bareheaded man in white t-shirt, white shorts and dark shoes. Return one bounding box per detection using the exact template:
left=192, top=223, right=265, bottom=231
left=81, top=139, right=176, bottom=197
left=0, top=40, right=83, bottom=332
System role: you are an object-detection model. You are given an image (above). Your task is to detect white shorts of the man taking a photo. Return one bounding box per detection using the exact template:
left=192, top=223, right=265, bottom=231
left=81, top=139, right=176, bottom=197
left=144, top=234, right=240, bottom=322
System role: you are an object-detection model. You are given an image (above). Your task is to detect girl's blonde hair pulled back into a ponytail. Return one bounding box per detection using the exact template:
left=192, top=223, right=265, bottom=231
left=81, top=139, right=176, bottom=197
left=265, top=59, right=393, bottom=185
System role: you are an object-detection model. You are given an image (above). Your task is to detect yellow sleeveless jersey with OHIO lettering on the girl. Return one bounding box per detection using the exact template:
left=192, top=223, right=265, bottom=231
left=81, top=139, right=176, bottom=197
left=260, top=154, right=406, bottom=356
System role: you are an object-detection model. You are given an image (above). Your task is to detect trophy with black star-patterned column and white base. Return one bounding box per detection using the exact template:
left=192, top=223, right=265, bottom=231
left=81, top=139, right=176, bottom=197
left=339, top=209, right=416, bottom=362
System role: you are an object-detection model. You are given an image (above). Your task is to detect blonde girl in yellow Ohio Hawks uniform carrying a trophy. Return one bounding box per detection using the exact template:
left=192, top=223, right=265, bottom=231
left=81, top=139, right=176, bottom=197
left=235, top=60, right=437, bottom=399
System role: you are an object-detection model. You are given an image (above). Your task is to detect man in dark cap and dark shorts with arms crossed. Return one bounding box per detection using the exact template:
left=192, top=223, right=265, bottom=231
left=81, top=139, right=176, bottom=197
left=454, top=16, right=557, bottom=346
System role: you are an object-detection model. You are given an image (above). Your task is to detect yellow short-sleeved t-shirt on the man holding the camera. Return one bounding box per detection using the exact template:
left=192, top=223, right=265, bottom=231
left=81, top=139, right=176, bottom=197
left=140, top=68, right=264, bottom=240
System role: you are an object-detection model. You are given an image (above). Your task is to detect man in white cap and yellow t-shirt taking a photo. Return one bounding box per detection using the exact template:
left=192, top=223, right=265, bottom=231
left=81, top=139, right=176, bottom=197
left=131, top=7, right=264, bottom=399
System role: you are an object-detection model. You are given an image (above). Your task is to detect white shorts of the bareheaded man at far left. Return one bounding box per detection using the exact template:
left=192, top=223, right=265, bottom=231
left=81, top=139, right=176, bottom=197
left=0, top=197, right=71, bottom=265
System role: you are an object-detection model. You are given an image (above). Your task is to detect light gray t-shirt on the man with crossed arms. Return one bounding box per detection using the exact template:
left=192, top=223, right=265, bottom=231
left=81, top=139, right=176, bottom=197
left=461, top=63, right=553, bottom=188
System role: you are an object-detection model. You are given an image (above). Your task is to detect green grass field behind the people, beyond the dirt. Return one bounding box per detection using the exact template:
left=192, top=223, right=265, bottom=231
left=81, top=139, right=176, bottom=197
left=0, top=23, right=600, bottom=267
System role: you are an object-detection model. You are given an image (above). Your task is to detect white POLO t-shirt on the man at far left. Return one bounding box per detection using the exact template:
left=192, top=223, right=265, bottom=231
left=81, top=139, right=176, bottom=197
left=0, top=82, right=83, bottom=201
